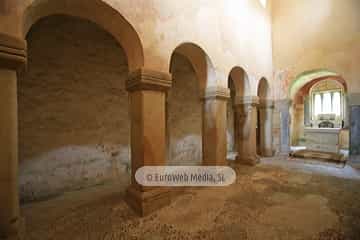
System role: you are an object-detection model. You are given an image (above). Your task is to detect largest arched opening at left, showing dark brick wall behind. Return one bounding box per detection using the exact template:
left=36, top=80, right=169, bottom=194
left=18, top=15, right=130, bottom=202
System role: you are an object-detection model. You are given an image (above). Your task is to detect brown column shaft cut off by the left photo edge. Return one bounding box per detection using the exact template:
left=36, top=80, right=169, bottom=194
left=0, top=69, right=19, bottom=238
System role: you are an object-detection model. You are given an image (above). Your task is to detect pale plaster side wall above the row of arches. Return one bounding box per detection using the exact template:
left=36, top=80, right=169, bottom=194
left=0, top=0, right=272, bottom=94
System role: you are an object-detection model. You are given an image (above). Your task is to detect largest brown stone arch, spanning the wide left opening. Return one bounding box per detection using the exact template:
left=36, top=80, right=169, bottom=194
left=22, top=0, right=144, bottom=71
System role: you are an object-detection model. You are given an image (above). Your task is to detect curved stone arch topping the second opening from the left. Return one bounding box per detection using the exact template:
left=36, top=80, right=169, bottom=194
left=170, top=42, right=216, bottom=94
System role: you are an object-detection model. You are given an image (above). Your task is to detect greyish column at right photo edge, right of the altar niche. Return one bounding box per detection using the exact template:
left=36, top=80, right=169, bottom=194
left=349, top=93, right=360, bottom=162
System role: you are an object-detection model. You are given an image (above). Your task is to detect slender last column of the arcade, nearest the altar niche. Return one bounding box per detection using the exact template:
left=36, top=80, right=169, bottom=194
left=258, top=100, right=274, bottom=157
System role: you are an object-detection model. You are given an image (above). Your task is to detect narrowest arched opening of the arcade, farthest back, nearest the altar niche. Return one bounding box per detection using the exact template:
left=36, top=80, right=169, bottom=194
left=256, top=78, right=272, bottom=157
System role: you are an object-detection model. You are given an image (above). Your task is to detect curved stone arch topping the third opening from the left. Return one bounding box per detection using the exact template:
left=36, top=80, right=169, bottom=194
left=229, top=66, right=251, bottom=97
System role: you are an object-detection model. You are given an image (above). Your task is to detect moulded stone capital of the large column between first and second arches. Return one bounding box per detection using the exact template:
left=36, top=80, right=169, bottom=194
left=126, top=68, right=172, bottom=92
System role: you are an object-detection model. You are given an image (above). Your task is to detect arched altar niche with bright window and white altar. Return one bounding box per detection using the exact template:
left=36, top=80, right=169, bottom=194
left=290, top=73, right=349, bottom=161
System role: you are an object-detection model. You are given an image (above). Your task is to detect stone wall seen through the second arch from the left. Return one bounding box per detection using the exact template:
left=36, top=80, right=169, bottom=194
left=168, top=54, right=202, bottom=165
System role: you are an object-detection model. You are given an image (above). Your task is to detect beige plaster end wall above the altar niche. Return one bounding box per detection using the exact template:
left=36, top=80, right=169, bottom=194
left=272, top=0, right=360, bottom=99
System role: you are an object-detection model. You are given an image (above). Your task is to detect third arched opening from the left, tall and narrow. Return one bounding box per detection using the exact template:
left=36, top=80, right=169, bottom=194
left=227, top=67, right=250, bottom=160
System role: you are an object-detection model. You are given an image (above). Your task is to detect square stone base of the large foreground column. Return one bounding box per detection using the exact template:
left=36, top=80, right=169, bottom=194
left=125, top=186, right=171, bottom=216
